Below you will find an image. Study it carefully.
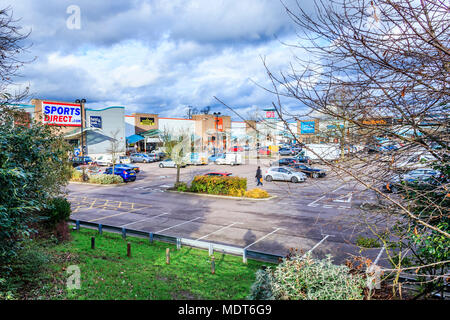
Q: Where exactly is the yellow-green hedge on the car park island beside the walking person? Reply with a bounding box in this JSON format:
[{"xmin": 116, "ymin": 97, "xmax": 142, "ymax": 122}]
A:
[{"xmin": 190, "ymin": 176, "xmax": 247, "ymax": 196}]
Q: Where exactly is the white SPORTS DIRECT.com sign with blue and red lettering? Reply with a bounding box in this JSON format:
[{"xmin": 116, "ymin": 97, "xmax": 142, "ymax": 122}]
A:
[{"xmin": 42, "ymin": 101, "xmax": 81, "ymax": 127}]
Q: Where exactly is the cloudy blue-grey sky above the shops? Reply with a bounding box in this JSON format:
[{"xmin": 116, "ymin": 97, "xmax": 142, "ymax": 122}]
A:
[{"xmin": 4, "ymin": 0, "xmax": 308, "ymax": 117}]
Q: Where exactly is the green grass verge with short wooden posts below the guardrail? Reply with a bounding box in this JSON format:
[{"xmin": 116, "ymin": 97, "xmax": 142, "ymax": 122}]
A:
[{"xmin": 32, "ymin": 229, "xmax": 269, "ymax": 300}]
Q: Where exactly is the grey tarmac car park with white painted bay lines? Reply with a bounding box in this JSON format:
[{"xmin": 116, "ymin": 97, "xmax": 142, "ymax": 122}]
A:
[{"xmin": 68, "ymin": 159, "xmax": 386, "ymax": 263}]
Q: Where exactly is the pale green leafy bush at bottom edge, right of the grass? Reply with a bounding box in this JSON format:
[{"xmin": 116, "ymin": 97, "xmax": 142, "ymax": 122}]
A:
[{"xmin": 249, "ymin": 255, "xmax": 365, "ymax": 300}]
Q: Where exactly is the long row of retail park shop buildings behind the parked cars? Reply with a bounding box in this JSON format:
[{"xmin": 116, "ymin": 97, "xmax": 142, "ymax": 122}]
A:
[{"xmin": 16, "ymin": 99, "xmax": 426, "ymax": 158}]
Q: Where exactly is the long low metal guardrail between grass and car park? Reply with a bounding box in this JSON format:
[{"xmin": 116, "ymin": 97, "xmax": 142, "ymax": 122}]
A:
[{"xmin": 69, "ymin": 219, "xmax": 284, "ymax": 263}]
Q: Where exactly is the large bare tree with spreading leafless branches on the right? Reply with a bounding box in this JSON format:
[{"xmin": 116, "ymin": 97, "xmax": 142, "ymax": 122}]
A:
[{"xmin": 218, "ymin": 0, "xmax": 450, "ymax": 294}]
